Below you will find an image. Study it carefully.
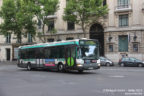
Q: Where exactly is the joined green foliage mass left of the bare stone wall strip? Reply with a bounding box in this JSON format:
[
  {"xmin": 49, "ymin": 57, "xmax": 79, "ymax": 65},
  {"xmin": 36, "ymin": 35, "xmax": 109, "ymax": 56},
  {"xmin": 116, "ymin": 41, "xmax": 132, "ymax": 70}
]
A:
[{"xmin": 0, "ymin": 0, "xmax": 58, "ymax": 41}]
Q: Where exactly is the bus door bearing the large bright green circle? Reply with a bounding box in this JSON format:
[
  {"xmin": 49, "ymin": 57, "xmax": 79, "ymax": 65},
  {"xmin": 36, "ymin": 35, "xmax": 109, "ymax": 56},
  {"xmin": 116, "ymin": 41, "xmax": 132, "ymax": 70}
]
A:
[{"xmin": 66, "ymin": 46, "xmax": 76, "ymax": 68}]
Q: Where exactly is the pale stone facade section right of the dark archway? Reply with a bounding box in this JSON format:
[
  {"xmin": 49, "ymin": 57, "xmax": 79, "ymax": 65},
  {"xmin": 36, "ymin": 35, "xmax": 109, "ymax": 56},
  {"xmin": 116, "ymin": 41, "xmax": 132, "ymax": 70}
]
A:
[{"xmin": 104, "ymin": 0, "xmax": 144, "ymax": 62}]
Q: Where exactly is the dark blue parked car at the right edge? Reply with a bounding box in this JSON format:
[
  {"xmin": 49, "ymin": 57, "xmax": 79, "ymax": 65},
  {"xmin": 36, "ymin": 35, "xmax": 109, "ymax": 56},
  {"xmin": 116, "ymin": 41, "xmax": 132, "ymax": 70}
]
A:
[{"xmin": 119, "ymin": 57, "xmax": 144, "ymax": 67}]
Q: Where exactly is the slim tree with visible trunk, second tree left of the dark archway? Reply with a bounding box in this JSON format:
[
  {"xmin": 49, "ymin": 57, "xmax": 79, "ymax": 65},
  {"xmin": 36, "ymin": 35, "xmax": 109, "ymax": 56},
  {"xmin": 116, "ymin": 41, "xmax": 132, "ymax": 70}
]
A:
[{"xmin": 36, "ymin": 0, "xmax": 58, "ymax": 42}]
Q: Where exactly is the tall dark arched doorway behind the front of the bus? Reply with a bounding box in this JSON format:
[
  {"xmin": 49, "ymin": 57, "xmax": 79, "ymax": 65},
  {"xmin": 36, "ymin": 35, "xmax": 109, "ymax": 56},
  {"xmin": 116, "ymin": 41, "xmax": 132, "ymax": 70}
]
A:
[{"xmin": 90, "ymin": 23, "xmax": 104, "ymax": 56}]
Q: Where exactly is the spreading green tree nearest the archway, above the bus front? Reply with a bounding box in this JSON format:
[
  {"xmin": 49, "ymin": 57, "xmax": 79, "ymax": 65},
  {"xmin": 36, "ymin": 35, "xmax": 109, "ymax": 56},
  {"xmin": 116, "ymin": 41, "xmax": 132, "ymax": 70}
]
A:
[{"xmin": 63, "ymin": 0, "xmax": 108, "ymax": 37}]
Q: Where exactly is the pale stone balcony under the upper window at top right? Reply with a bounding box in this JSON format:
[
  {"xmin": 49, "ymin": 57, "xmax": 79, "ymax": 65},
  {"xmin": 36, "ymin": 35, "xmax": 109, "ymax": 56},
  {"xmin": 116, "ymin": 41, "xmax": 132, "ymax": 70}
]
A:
[{"xmin": 115, "ymin": 4, "xmax": 132, "ymax": 13}]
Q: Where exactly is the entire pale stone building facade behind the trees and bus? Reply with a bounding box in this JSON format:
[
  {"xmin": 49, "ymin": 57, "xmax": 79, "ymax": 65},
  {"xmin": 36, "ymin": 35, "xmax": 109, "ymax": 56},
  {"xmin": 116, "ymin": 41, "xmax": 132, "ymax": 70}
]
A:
[{"xmin": 0, "ymin": 0, "xmax": 144, "ymax": 62}]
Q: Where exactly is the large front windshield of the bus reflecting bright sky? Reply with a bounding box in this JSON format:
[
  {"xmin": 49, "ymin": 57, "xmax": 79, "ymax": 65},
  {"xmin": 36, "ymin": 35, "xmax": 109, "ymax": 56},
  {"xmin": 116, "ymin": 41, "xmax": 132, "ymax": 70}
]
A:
[{"xmin": 80, "ymin": 40, "xmax": 99, "ymax": 59}]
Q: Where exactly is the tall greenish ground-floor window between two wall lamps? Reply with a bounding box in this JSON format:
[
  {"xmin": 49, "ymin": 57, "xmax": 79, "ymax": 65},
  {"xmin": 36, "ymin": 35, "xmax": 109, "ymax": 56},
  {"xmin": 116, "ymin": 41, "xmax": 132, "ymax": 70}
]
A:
[{"xmin": 119, "ymin": 35, "xmax": 128, "ymax": 52}]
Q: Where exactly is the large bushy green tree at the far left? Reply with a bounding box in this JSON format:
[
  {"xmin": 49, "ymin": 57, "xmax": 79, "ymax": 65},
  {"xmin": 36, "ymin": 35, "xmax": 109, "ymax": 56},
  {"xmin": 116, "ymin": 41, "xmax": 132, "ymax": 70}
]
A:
[{"xmin": 0, "ymin": 0, "xmax": 36, "ymax": 43}]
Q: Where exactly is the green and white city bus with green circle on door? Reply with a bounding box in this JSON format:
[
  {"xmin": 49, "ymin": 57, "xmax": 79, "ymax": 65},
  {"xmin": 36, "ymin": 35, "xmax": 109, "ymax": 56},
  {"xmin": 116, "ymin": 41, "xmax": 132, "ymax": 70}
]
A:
[{"xmin": 18, "ymin": 39, "xmax": 100, "ymax": 72}]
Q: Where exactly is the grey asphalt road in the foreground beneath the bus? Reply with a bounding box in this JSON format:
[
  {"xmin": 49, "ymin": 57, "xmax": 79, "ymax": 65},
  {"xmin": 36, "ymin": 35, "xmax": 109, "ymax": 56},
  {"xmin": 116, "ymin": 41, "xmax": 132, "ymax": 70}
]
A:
[{"xmin": 0, "ymin": 64, "xmax": 144, "ymax": 96}]
